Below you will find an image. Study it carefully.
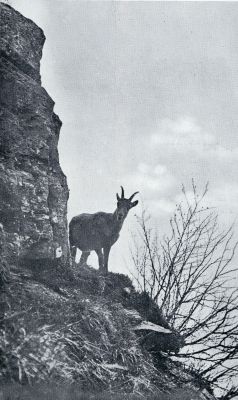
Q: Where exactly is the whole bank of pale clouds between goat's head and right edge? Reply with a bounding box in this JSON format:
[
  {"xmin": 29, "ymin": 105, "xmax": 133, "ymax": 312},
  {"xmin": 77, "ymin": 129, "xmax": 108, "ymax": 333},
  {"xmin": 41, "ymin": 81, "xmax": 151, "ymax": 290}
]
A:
[{"xmin": 125, "ymin": 117, "xmax": 238, "ymax": 224}]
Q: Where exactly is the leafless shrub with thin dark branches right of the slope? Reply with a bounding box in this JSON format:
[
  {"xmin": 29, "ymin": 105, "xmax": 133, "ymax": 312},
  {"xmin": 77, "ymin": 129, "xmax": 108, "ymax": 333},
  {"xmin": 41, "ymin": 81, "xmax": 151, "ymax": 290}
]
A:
[{"xmin": 131, "ymin": 182, "xmax": 238, "ymax": 398}]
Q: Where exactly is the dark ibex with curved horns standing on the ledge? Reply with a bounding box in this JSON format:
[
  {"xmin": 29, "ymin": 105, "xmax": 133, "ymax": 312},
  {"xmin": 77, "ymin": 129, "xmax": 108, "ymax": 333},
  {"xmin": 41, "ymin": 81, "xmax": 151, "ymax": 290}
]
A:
[{"xmin": 69, "ymin": 186, "xmax": 139, "ymax": 274}]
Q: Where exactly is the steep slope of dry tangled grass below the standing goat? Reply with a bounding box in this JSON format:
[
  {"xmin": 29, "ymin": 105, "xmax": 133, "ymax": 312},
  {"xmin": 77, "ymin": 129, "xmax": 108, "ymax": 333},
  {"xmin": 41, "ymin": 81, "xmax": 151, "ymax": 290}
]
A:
[{"xmin": 0, "ymin": 269, "xmax": 212, "ymax": 400}]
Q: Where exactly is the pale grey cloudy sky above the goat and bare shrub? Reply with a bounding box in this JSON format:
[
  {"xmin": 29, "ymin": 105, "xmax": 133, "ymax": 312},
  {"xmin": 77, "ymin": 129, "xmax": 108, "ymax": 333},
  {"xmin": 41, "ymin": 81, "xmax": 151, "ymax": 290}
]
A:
[{"xmin": 8, "ymin": 0, "xmax": 238, "ymax": 271}]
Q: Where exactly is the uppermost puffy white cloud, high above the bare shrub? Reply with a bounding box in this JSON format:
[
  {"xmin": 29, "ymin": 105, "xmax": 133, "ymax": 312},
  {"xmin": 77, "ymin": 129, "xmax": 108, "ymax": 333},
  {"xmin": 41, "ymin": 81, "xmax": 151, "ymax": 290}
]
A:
[{"xmin": 149, "ymin": 117, "xmax": 238, "ymax": 161}]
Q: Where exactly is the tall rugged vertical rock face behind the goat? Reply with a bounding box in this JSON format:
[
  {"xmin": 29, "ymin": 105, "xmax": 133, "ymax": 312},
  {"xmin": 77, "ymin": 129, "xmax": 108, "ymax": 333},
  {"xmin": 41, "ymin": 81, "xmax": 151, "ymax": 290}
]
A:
[{"xmin": 0, "ymin": 3, "xmax": 69, "ymax": 265}]
